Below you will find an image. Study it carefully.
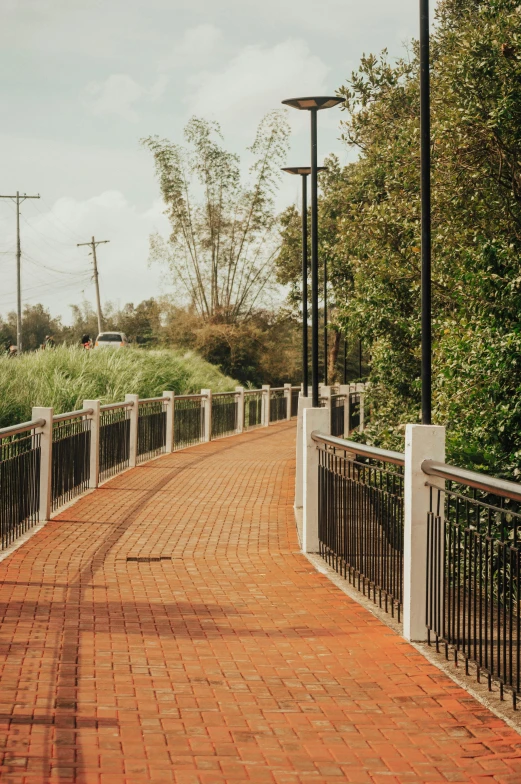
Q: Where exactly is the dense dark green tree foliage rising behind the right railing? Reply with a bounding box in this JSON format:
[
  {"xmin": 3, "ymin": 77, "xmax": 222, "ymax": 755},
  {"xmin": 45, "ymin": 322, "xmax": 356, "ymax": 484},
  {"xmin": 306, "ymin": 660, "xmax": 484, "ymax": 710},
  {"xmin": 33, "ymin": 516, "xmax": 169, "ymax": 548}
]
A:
[{"xmin": 278, "ymin": 0, "xmax": 521, "ymax": 476}]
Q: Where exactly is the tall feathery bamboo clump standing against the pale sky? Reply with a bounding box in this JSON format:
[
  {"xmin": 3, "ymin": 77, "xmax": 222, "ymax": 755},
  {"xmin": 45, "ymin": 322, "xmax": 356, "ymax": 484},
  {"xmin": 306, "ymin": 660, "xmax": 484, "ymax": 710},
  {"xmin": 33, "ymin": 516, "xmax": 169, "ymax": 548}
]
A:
[{"xmin": 143, "ymin": 112, "xmax": 289, "ymax": 324}]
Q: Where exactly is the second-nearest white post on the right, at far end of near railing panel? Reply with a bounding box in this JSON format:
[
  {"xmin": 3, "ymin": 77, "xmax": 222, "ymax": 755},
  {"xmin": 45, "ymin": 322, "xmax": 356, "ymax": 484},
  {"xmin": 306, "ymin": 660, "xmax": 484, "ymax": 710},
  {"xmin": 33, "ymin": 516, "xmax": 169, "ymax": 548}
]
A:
[{"xmin": 302, "ymin": 408, "xmax": 330, "ymax": 553}]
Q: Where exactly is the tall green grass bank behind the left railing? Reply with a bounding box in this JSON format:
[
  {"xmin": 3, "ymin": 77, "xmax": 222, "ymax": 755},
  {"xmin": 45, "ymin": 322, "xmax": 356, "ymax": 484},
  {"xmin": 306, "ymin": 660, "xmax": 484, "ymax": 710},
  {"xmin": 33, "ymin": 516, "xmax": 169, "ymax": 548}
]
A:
[{"xmin": 0, "ymin": 346, "xmax": 236, "ymax": 427}]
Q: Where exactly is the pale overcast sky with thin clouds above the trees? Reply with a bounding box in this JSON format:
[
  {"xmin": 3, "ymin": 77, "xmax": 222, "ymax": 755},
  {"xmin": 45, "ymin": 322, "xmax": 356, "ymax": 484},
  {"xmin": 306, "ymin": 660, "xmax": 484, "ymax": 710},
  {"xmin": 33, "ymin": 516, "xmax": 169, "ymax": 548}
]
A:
[{"xmin": 0, "ymin": 0, "xmax": 418, "ymax": 321}]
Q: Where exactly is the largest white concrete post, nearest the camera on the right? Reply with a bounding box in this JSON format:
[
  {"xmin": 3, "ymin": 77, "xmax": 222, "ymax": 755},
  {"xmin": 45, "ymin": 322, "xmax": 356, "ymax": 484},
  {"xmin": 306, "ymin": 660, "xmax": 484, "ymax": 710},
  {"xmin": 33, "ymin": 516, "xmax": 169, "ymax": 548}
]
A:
[{"xmin": 403, "ymin": 425, "xmax": 445, "ymax": 642}]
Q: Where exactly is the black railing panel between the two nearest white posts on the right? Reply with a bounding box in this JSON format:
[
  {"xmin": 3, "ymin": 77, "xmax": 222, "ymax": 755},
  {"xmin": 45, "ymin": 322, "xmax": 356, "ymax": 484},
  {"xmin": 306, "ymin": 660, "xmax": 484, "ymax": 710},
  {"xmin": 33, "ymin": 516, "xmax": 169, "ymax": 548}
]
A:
[{"xmin": 313, "ymin": 434, "xmax": 404, "ymax": 620}]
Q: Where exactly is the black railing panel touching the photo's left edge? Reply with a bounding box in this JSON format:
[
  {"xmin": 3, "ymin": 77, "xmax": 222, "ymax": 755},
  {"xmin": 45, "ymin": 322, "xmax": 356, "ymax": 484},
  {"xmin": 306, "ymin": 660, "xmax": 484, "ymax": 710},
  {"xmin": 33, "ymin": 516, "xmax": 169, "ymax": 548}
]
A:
[{"xmin": 0, "ymin": 425, "xmax": 41, "ymax": 550}]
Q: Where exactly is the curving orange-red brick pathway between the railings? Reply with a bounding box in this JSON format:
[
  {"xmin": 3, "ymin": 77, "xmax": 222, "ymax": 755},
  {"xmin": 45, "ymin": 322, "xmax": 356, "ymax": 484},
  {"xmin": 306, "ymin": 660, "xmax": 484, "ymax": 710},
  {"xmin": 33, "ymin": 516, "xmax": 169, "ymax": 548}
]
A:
[{"xmin": 0, "ymin": 423, "xmax": 521, "ymax": 784}]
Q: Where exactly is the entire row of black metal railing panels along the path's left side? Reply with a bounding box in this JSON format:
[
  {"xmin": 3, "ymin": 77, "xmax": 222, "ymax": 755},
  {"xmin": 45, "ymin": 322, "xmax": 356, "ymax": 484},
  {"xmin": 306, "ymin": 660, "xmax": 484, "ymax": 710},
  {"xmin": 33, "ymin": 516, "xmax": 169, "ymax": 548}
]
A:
[{"xmin": 0, "ymin": 387, "xmax": 299, "ymax": 548}]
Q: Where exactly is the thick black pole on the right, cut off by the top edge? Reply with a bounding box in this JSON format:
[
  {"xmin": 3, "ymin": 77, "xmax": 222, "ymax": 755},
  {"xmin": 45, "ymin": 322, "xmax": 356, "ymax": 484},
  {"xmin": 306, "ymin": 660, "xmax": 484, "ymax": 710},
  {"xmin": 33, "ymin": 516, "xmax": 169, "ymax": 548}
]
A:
[{"xmin": 420, "ymin": 0, "xmax": 432, "ymax": 425}]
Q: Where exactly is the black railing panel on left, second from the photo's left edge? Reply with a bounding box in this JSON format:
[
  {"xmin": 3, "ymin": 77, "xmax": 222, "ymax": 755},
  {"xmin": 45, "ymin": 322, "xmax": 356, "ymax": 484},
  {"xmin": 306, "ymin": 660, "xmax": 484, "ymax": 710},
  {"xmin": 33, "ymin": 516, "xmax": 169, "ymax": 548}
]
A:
[{"xmin": 51, "ymin": 412, "xmax": 91, "ymax": 510}]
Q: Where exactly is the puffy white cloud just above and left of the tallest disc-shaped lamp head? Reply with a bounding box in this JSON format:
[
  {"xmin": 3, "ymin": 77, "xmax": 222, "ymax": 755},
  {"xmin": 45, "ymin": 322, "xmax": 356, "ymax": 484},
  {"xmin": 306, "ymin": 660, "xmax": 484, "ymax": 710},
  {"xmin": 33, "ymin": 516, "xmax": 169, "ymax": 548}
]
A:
[{"xmin": 187, "ymin": 39, "xmax": 329, "ymax": 122}]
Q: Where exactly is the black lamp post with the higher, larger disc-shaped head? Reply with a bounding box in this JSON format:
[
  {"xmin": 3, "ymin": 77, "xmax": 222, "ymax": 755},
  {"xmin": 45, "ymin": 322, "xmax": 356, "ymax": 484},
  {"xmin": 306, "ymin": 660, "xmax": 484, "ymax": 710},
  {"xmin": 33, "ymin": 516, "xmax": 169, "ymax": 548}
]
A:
[{"xmin": 282, "ymin": 96, "xmax": 345, "ymax": 408}]
